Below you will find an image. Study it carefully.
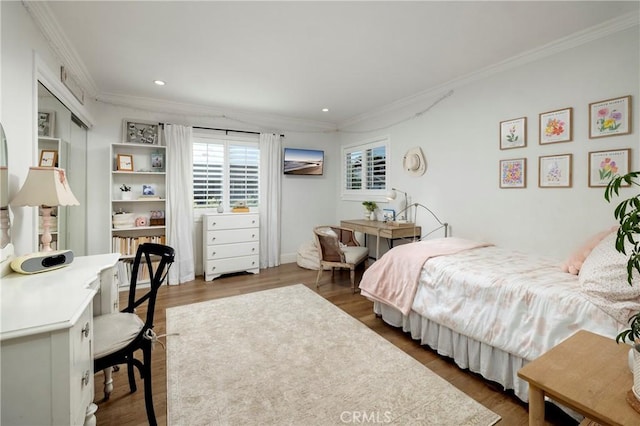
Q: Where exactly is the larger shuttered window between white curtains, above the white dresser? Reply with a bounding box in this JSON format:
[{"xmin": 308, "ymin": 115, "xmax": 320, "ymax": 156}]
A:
[{"xmin": 193, "ymin": 135, "xmax": 260, "ymax": 213}]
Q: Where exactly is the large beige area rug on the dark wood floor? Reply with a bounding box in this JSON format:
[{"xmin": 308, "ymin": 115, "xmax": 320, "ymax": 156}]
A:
[{"xmin": 167, "ymin": 284, "xmax": 500, "ymax": 426}]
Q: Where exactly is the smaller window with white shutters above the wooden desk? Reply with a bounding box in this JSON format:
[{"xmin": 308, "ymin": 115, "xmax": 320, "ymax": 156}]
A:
[{"xmin": 342, "ymin": 138, "xmax": 389, "ymax": 200}]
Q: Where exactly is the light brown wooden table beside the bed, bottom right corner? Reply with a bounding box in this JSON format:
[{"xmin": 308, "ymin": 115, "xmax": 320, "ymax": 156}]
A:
[{"xmin": 518, "ymin": 330, "xmax": 640, "ymax": 426}]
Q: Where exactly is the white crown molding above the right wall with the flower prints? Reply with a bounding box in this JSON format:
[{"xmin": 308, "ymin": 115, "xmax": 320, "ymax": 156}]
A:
[{"xmin": 338, "ymin": 12, "xmax": 640, "ymax": 129}]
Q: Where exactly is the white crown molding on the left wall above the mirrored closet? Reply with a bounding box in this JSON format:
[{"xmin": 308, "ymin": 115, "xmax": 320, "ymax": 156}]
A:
[{"xmin": 22, "ymin": 0, "xmax": 99, "ymax": 97}]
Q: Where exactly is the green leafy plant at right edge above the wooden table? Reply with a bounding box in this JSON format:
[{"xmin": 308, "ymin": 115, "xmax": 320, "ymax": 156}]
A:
[{"xmin": 604, "ymin": 171, "xmax": 640, "ymax": 344}]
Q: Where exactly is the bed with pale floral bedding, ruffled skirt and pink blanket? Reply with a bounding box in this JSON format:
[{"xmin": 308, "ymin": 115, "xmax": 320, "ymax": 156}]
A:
[{"xmin": 360, "ymin": 236, "xmax": 640, "ymax": 402}]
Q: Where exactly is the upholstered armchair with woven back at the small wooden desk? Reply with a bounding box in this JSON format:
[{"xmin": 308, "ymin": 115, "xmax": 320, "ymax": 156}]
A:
[{"xmin": 313, "ymin": 226, "xmax": 369, "ymax": 293}]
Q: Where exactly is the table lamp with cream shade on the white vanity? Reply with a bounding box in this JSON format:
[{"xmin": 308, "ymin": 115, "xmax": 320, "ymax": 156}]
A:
[{"xmin": 9, "ymin": 167, "xmax": 80, "ymax": 252}]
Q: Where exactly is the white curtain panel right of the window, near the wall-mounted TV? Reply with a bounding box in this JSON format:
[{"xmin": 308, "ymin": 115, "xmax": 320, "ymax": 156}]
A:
[{"xmin": 260, "ymin": 133, "xmax": 282, "ymax": 268}]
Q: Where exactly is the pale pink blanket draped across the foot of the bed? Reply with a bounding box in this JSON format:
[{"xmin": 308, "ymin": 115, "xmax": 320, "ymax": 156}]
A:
[{"xmin": 360, "ymin": 237, "xmax": 491, "ymax": 315}]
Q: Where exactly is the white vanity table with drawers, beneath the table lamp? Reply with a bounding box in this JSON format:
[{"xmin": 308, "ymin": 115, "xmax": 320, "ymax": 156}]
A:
[{"xmin": 0, "ymin": 253, "xmax": 120, "ymax": 425}]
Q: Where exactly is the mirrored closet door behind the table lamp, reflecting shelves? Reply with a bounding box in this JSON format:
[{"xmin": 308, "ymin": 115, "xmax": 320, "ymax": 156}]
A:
[{"xmin": 37, "ymin": 82, "xmax": 87, "ymax": 256}]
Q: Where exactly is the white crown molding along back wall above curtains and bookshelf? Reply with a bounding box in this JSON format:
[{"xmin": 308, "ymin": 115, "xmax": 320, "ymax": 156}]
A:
[{"xmin": 96, "ymin": 93, "xmax": 336, "ymax": 133}]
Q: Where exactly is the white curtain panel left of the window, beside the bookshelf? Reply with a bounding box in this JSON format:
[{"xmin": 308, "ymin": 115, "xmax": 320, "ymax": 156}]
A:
[{"xmin": 164, "ymin": 124, "xmax": 195, "ymax": 284}]
